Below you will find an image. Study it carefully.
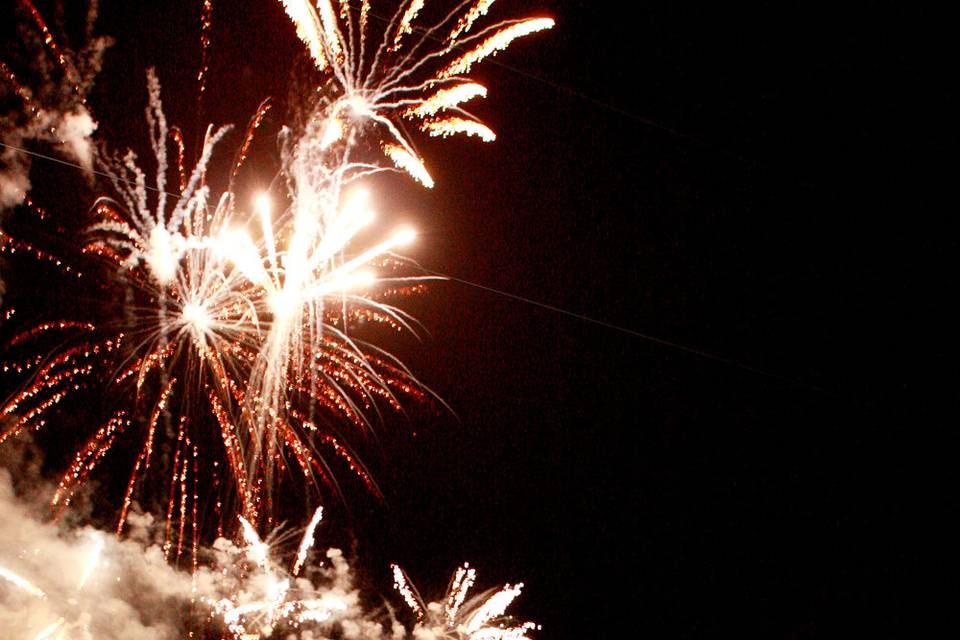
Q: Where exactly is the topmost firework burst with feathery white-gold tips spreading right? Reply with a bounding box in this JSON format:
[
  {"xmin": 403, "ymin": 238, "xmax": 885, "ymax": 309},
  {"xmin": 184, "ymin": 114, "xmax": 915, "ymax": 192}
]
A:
[{"xmin": 280, "ymin": 0, "xmax": 554, "ymax": 188}]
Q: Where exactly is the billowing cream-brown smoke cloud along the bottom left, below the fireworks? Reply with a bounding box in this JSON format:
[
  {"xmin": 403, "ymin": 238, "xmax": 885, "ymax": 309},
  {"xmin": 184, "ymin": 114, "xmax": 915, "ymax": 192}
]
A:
[{"xmin": 0, "ymin": 442, "xmax": 407, "ymax": 640}]
